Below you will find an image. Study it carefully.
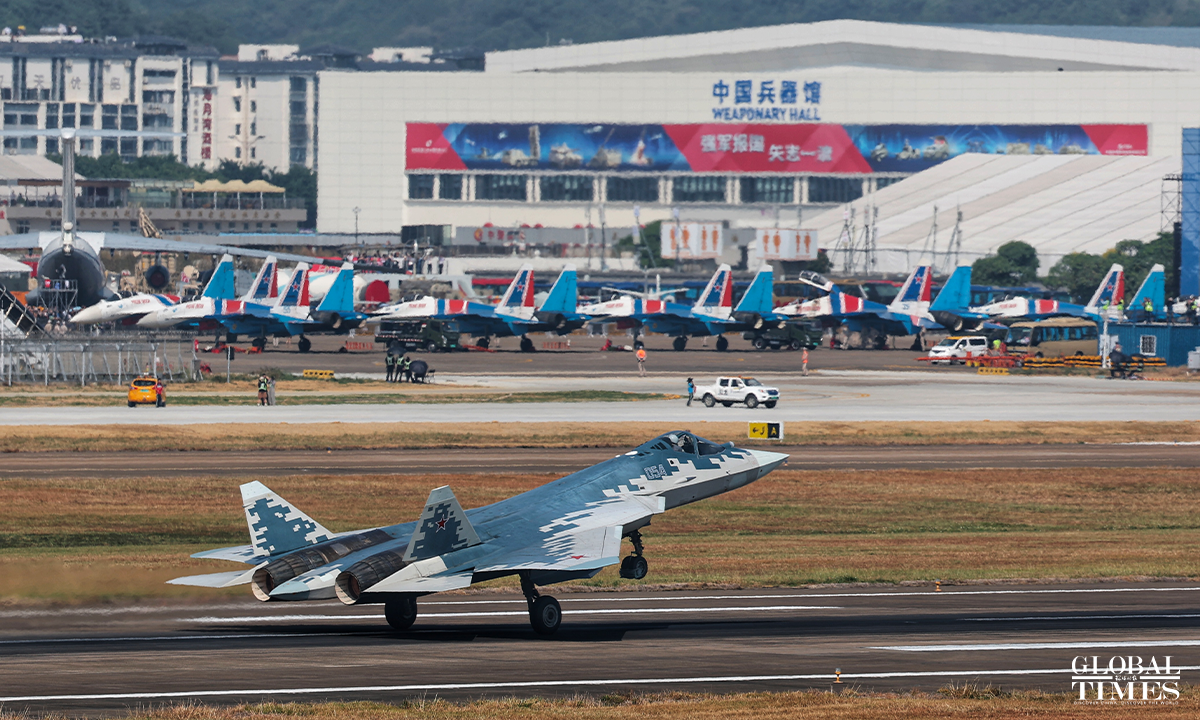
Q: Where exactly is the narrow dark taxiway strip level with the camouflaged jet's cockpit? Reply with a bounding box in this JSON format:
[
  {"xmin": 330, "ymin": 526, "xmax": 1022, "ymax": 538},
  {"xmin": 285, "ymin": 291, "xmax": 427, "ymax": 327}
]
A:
[{"xmin": 0, "ymin": 444, "xmax": 1200, "ymax": 478}]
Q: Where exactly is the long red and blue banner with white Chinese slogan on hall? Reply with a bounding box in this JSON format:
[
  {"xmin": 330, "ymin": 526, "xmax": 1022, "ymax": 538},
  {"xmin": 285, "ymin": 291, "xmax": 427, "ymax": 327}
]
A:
[{"xmin": 406, "ymin": 122, "xmax": 1148, "ymax": 174}]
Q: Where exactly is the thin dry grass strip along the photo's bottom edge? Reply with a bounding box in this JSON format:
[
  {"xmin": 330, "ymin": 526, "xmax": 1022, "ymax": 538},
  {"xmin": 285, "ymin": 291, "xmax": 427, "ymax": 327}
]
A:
[{"xmin": 49, "ymin": 685, "xmax": 1200, "ymax": 720}]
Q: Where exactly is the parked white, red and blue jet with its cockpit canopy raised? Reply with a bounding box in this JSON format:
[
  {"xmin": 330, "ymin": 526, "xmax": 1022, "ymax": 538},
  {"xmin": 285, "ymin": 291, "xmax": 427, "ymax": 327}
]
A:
[{"xmin": 776, "ymin": 265, "xmax": 940, "ymax": 337}]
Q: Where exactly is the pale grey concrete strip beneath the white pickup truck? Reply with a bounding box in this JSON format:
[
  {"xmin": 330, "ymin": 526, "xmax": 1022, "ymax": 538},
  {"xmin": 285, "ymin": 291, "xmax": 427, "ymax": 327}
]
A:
[{"xmin": 9, "ymin": 368, "xmax": 1200, "ymax": 425}]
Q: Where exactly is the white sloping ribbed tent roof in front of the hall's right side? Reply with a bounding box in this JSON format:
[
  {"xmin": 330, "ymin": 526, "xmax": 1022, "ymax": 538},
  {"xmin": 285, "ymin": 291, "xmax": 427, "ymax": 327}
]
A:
[{"xmin": 804, "ymin": 154, "xmax": 1181, "ymax": 272}]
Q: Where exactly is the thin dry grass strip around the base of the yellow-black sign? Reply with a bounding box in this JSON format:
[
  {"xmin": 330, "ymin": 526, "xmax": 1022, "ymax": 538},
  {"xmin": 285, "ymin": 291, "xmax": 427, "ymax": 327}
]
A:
[{"xmin": 7, "ymin": 420, "xmax": 1200, "ymax": 452}]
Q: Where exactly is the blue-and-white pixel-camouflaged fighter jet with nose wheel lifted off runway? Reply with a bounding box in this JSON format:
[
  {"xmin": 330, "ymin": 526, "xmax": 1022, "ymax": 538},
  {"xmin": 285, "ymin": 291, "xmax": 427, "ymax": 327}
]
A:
[{"xmin": 169, "ymin": 431, "xmax": 787, "ymax": 635}]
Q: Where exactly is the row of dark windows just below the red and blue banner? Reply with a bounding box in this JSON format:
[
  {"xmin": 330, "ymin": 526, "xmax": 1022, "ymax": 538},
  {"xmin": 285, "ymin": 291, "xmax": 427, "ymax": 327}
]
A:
[{"xmin": 408, "ymin": 173, "xmax": 902, "ymax": 205}]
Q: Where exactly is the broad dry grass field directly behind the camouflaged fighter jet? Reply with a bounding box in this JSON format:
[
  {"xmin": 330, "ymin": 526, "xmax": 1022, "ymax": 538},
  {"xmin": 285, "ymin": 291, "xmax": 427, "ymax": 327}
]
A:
[{"xmin": 0, "ymin": 468, "xmax": 1200, "ymax": 602}]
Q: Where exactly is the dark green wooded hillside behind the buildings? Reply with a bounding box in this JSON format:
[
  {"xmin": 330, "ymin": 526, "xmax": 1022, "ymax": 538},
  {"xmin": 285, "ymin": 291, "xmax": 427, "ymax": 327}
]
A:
[{"xmin": 0, "ymin": 0, "xmax": 1200, "ymax": 53}]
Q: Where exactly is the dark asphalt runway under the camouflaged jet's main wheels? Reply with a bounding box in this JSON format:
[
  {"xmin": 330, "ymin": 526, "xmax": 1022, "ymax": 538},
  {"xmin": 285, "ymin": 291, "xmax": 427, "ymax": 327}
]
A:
[{"xmin": 0, "ymin": 585, "xmax": 1200, "ymax": 715}]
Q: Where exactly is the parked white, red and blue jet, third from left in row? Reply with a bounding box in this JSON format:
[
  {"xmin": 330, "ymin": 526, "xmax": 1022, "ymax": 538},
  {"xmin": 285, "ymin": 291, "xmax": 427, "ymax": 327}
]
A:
[{"xmin": 370, "ymin": 264, "xmax": 588, "ymax": 352}]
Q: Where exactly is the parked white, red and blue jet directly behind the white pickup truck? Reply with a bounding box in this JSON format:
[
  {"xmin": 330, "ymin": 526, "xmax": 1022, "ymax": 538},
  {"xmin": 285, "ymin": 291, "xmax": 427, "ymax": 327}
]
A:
[{"xmin": 581, "ymin": 264, "xmax": 784, "ymax": 350}]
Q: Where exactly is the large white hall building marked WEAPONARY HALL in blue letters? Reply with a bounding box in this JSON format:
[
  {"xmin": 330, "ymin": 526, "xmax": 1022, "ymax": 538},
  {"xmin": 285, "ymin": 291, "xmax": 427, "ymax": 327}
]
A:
[{"xmin": 318, "ymin": 20, "xmax": 1200, "ymax": 271}]
